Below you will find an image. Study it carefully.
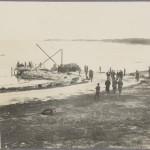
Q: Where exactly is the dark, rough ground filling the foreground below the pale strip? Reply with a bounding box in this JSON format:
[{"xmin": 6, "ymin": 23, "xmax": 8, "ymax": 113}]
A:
[{"xmin": 0, "ymin": 78, "xmax": 150, "ymax": 148}]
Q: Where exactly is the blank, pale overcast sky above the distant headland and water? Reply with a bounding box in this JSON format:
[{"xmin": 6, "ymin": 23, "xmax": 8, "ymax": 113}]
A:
[{"xmin": 0, "ymin": 2, "xmax": 150, "ymax": 40}]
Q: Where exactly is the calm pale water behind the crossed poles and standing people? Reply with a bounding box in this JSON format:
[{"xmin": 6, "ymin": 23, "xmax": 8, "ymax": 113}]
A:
[{"xmin": 0, "ymin": 41, "xmax": 150, "ymax": 80}]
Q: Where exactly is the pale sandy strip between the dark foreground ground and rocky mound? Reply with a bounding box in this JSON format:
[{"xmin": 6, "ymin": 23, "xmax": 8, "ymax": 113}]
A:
[{"xmin": 0, "ymin": 72, "xmax": 141, "ymax": 106}]
